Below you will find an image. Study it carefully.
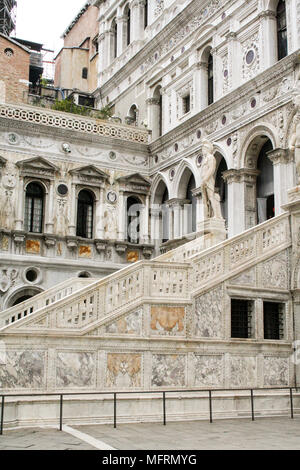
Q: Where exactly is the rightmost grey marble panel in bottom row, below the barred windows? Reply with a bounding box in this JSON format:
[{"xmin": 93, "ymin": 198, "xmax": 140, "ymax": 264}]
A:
[{"xmin": 264, "ymin": 356, "xmax": 289, "ymax": 387}]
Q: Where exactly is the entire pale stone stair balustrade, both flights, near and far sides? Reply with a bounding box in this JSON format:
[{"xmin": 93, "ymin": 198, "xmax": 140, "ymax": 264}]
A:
[{"xmin": 0, "ymin": 213, "xmax": 291, "ymax": 335}]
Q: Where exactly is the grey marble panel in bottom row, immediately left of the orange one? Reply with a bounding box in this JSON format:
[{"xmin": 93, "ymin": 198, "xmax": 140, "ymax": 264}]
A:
[{"xmin": 56, "ymin": 352, "xmax": 95, "ymax": 388}]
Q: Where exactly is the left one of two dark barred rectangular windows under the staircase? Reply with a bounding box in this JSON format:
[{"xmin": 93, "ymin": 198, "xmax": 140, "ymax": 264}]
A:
[{"xmin": 231, "ymin": 299, "xmax": 253, "ymax": 338}]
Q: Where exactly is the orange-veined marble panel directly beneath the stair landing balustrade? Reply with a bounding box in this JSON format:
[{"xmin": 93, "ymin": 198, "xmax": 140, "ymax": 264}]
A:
[{"xmin": 150, "ymin": 306, "xmax": 185, "ymax": 335}]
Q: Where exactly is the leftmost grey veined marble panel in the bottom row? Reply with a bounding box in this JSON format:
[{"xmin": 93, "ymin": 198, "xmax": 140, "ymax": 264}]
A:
[{"xmin": 0, "ymin": 351, "xmax": 46, "ymax": 389}]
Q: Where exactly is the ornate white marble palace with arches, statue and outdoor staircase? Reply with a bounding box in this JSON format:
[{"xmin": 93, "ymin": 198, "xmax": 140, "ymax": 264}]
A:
[{"xmin": 0, "ymin": 0, "xmax": 300, "ymax": 422}]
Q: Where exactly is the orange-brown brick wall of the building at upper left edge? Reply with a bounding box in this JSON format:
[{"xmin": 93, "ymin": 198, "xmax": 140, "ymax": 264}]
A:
[{"xmin": 0, "ymin": 36, "xmax": 30, "ymax": 103}]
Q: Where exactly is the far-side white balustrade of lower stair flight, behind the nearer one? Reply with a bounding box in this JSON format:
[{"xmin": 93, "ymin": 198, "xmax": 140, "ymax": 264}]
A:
[{"xmin": 0, "ymin": 278, "xmax": 96, "ymax": 327}]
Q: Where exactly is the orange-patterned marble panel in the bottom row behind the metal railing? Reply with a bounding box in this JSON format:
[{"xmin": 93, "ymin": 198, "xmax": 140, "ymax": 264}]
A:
[{"xmin": 106, "ymin": 353, "xmax": 142, "ymax": 388}]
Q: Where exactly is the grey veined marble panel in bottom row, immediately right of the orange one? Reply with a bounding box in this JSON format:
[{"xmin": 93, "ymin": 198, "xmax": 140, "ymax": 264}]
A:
[{"xmin": 151, "ymin": 354, "xmax": 186, "ymax": 387}]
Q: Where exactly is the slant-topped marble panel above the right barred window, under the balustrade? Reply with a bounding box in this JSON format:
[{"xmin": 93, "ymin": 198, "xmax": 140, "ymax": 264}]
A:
[{"xmin": 261, "ymin": 251, "xmax": 288, "ymax": 289}]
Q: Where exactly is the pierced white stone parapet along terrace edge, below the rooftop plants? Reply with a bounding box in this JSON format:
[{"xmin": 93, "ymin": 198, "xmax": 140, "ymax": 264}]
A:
[{"xmin": 0, "ymin": 104, "xmax": 149, "ymax": 144}]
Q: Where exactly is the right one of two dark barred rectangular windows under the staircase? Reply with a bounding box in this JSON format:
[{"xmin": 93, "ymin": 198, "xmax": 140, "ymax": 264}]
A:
[{"xmin": 264, "ymin": 302, "xmax": 284, "ymax": 339}]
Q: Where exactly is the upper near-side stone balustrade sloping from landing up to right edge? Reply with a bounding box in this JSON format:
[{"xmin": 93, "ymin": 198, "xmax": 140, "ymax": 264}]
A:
[{"xmin": 189, "ymin": 213, "xmax": 291, "ymax": 291}]
